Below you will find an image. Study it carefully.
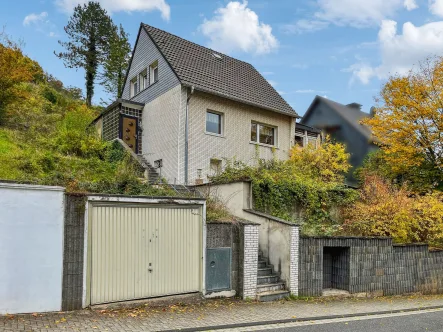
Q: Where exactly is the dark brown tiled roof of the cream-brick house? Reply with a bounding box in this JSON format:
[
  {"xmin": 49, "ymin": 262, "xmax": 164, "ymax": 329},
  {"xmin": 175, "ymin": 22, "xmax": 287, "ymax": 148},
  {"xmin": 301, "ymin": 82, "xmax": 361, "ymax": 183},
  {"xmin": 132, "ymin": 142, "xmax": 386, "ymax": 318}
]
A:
[{"xmin": 142, "ymin": 24, "xmax": 298, "ymax": 117}]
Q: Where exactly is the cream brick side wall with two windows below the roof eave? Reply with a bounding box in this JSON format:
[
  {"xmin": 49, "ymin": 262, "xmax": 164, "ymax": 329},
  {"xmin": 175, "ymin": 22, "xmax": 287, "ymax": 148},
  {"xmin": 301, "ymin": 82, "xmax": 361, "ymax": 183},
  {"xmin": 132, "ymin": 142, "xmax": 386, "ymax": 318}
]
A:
[{"xmin": 188, "ymin": 91, "xmax": 295, "ymax": 184}]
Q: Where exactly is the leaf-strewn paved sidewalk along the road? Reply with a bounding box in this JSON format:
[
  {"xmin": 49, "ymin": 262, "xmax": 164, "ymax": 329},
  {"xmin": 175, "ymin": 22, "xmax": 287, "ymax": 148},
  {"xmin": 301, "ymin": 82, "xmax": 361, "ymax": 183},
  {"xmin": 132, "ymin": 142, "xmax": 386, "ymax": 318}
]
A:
[{"xmin": 0, "ymin": 295, "xmax": 443, "ymax": 332}]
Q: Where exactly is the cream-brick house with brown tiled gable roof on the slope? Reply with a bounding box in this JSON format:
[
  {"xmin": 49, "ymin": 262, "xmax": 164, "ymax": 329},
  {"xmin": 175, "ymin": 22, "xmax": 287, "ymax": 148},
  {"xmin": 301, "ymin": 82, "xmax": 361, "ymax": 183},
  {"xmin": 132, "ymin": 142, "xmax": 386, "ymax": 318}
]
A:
[{"xmin": 95, "ymin": 24, "xmax": 298, "ymax": 184}]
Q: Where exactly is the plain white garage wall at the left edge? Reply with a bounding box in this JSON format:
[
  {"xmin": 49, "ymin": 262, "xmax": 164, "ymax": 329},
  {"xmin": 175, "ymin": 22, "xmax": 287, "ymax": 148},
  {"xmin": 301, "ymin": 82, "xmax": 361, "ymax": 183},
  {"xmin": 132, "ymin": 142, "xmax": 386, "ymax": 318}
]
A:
[{"xmin": 0, "ymin": 183, "xmax": 64, "ymax": 314}]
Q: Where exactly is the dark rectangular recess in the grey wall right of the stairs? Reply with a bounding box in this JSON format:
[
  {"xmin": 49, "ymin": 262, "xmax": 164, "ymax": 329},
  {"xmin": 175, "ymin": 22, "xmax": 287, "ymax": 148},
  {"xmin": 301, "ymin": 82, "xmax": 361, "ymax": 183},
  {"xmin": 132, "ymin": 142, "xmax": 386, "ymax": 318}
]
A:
[{"xmin": 323, "ymin": 247, "xmax": 350, "ymax": 291}]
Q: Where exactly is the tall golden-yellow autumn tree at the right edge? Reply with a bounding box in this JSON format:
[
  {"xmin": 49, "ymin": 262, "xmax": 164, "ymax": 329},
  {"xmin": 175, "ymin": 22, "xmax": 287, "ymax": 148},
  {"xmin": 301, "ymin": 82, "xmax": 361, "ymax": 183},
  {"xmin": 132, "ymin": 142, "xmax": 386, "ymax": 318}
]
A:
[{"xmin": 363, "ymin": 57, "xmax": 443, "ymax": 187}]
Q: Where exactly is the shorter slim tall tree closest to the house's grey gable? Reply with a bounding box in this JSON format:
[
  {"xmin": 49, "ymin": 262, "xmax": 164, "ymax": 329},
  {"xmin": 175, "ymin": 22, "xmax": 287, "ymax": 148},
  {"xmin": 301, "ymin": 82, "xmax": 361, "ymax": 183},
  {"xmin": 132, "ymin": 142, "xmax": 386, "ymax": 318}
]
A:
[{"xmin": 101, "ymin": 24, "xmax": 131, "ymax": 98}]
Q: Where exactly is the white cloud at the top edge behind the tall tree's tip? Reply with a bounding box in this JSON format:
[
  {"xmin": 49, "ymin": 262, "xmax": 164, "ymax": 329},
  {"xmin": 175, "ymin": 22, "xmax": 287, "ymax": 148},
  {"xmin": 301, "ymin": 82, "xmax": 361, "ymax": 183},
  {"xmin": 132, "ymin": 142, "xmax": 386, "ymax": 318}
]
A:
[{"xmin": 55, "ymin": 0, "xmax": 171, "ymax": 21}]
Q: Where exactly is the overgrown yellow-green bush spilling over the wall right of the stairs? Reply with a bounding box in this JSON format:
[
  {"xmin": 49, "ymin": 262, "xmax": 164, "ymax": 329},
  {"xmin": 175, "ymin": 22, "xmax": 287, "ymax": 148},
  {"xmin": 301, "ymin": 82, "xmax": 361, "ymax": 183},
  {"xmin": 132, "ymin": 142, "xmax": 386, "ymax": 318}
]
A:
[{"xmin": 212, "ymin": 142, "xmax": 357, "ymax": 234}]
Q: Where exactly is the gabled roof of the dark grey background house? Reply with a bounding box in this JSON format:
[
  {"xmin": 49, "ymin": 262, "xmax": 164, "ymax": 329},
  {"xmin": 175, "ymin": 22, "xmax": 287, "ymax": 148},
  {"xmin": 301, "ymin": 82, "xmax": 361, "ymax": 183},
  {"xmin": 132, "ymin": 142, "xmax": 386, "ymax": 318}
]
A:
[{"xmin": 300, "ymin": 96, "xmax": 373, "ymax": 140}]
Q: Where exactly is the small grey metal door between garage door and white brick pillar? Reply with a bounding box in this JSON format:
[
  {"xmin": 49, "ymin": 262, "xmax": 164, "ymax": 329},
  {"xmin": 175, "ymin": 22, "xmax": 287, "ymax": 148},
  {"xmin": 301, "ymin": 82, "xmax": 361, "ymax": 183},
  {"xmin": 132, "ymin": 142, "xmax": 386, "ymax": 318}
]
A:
[{"xmin": 206, "ymin": 248, "xmax": 231, "ymax": 291}]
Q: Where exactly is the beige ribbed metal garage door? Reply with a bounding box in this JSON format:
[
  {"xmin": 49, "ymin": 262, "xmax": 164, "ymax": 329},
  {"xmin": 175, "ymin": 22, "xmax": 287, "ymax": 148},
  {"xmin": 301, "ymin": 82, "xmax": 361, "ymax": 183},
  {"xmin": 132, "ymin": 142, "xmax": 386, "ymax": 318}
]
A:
[{"xmin": 89, "ymin": 204, "xmax": 202, "ymax": 304}]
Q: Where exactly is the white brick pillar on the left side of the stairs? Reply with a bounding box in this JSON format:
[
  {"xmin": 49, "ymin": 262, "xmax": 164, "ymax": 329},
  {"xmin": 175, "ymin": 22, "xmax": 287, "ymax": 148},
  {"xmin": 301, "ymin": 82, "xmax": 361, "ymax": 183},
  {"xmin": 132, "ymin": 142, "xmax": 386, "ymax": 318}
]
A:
[{"xmin": 243, "ymin": 225, "xmax": 259, "ymax": 299}]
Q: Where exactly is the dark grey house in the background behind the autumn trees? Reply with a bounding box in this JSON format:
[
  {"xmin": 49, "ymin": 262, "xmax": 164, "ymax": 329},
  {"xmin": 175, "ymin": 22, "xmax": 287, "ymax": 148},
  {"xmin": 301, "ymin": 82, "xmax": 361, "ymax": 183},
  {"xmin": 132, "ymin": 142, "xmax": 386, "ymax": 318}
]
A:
[{"xmin": 300, "ymin": 96, "xmax": 377, "ymax": 185}]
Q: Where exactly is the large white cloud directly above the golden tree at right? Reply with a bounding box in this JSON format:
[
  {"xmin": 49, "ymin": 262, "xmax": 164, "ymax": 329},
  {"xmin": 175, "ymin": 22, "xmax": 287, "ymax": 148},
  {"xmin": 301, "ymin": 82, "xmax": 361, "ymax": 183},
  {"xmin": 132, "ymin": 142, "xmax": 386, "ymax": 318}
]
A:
[{"xmin": 343, "ymin": 20, "xmax": 443, "ymax": 84}]
